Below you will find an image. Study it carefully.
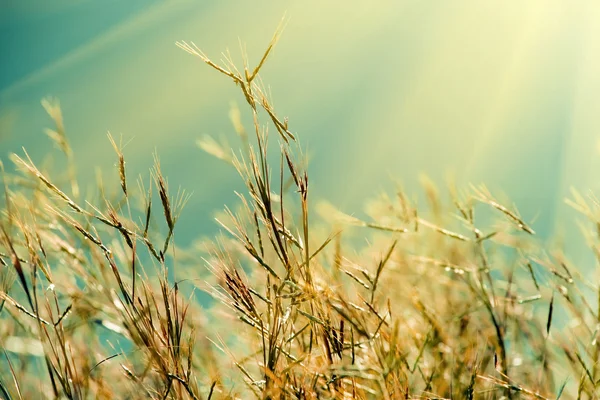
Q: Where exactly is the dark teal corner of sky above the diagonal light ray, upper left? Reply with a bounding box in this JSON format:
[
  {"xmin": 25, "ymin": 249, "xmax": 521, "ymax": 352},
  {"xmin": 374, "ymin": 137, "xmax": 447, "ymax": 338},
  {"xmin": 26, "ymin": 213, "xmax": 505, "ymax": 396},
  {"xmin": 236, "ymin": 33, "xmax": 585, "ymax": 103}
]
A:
[{"xmin": 0, "ymin": 0, "xmax": 163, "ymax": 90}]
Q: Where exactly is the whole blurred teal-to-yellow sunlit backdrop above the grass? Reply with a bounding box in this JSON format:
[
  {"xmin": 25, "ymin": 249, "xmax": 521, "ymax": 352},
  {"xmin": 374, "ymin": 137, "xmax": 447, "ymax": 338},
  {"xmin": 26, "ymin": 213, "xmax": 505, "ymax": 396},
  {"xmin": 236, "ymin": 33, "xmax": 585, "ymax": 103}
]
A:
[{"xmin": 0, "ymin": 0, "xmax": 600, "ymax": 266}]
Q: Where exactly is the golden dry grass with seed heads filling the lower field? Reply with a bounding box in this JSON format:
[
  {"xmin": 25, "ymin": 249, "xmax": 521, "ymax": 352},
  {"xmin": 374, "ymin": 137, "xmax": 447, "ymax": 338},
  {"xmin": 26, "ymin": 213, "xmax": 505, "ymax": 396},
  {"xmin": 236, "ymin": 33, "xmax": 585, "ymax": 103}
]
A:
[{"xmin": 0, "ymin": 26, "xmax": 600, "ymax": 399}]
